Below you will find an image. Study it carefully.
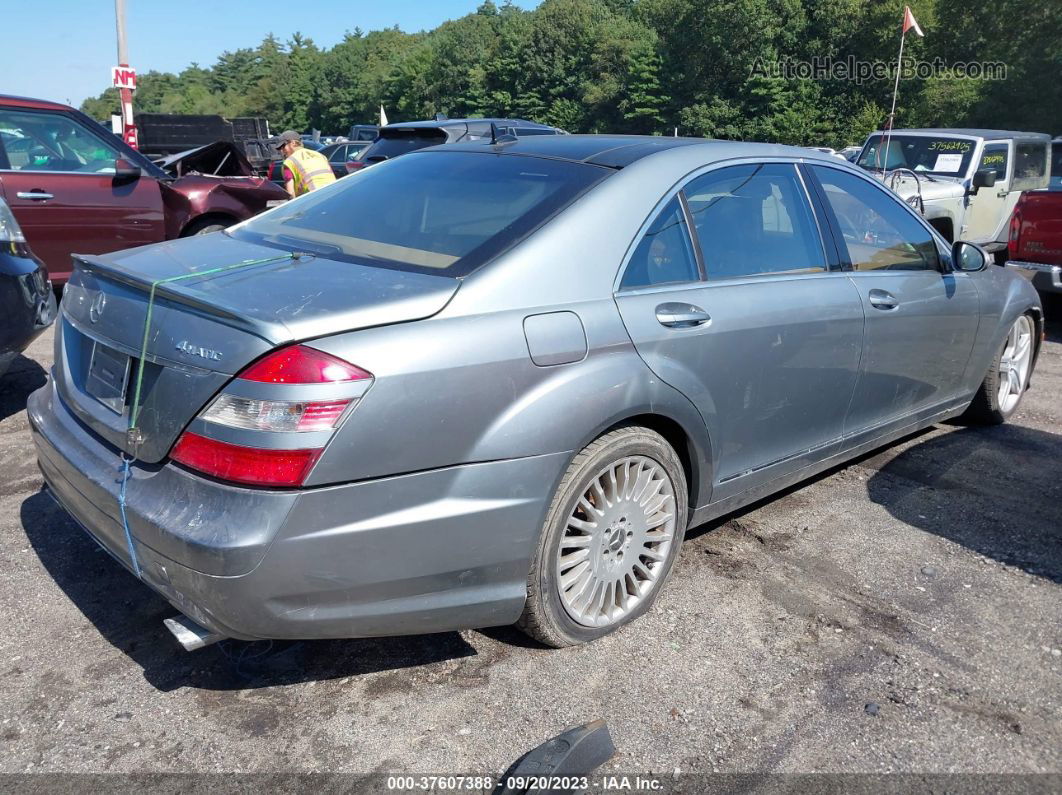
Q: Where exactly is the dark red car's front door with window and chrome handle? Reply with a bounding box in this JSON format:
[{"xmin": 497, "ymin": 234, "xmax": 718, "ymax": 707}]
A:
[{"xmin": 0, "ymin": 107, "xmax": 165, "ymax": 281}]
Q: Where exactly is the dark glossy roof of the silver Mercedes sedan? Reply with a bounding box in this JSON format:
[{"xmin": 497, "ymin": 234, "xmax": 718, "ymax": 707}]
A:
[{"xmin": 433, "ymin": 135, "xmax": 840, "ymax": 169}]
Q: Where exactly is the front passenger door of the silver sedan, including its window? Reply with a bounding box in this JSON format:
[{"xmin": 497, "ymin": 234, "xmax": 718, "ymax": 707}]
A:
[{"xmin": 809, "ymin": 159, "xmax": 980, "ymax": 436}]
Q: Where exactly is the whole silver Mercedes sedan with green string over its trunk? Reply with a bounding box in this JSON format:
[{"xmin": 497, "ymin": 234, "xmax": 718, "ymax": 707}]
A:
[{"xmin": 29, "ymin": 136, "xmax": 1043, "ymax": 647}]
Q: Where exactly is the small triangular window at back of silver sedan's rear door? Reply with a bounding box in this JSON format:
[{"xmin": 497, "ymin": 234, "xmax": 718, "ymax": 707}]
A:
[{"xmin": 619, "ymin": 197, "xmax": 700, "ymax": 290}]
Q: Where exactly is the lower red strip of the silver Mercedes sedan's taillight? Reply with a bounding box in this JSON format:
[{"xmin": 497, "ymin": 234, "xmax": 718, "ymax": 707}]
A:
[{"xmin": 171, "ymin": 431, "xmax": 321, "ymax": 486}]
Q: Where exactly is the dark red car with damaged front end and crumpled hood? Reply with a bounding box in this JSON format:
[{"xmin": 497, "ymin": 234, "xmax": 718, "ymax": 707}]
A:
[{"xmin": 0, "ymin": 96, "xmax": 288, "ymax": 283}]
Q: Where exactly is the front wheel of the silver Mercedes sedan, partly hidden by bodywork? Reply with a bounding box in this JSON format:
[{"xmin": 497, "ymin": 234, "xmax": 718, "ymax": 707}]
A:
[{"xmin": 962, "ymin": 314, "xmax": 1037, "ymax": 425}]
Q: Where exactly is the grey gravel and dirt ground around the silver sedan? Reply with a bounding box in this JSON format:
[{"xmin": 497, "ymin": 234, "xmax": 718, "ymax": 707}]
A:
[{"xmin": 0, "ymin": 301, "xmax": 1062, "ymax": 777}]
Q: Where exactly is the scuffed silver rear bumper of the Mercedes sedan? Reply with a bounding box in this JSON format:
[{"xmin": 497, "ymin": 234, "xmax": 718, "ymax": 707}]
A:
[{"xmin": 28, "ymin": 375, "xmax": 568, "ymax": 639}]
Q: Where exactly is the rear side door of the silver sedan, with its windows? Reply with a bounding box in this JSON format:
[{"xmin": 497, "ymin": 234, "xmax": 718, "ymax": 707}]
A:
[{"xmin": 616, "ymin": 162, "xmax": 863, "ymax": 499}]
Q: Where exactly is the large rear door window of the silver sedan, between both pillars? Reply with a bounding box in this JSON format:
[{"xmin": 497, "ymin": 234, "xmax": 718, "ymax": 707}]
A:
[{"xmin": 685, "ymin": 163, "xmax": 826, "ymax": 281}]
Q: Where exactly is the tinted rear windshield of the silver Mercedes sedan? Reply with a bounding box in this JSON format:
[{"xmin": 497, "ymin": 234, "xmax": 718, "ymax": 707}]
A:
[{"xmin": 232, "ymin": 150, "xmax": 613, "ymax": 276}]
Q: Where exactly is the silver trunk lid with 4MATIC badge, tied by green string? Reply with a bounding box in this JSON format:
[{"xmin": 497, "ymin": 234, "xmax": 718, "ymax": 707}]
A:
[{"xmin": 55, "ymin": 235, "xmax": 460, "ymax": 463}]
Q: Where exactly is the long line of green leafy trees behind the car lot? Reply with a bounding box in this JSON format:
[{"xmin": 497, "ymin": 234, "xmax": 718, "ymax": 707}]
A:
[{"xmin": 82, "ymin": 0, "xmax": 1062, "ymax": 146}]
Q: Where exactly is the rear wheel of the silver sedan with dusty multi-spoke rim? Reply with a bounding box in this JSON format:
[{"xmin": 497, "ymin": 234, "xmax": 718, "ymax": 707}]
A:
[{"xmin": 517, "ymin": 426, "xmax": 688, "ymax": 649}]
